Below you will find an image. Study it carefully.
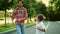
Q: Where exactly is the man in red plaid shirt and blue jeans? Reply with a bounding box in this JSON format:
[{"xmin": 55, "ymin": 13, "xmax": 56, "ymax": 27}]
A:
[{"xmin": 11, "ymin": 0, "xmax": 28, "ymax": 34}]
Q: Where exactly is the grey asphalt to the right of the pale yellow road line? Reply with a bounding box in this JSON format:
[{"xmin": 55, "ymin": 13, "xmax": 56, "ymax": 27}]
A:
[{"xmin": 46, "ymin": 22, "xmax": 60, "ymax": 34}]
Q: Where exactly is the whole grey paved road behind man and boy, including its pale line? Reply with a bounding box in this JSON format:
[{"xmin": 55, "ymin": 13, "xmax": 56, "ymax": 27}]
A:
[{"xmin": 1, "ymin": 22, "xmax": 60, "ymax": 34}]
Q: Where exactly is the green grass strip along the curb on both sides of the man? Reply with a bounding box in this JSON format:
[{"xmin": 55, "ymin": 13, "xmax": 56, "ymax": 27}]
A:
[{"xmin": 0, "ymin": 22, "xmax": 34, "ymax": 32}]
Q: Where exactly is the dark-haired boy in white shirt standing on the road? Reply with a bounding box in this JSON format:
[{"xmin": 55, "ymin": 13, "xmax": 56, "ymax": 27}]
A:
[{"xmin": 36, "ymin": 14, "xmax": 45, "ymax": 34}]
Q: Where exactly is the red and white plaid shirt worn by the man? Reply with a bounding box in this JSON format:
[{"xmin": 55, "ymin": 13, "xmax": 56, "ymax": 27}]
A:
[{"xmin": 12, "ymin": 7, "xmax": 28, "ymax": 23}]
